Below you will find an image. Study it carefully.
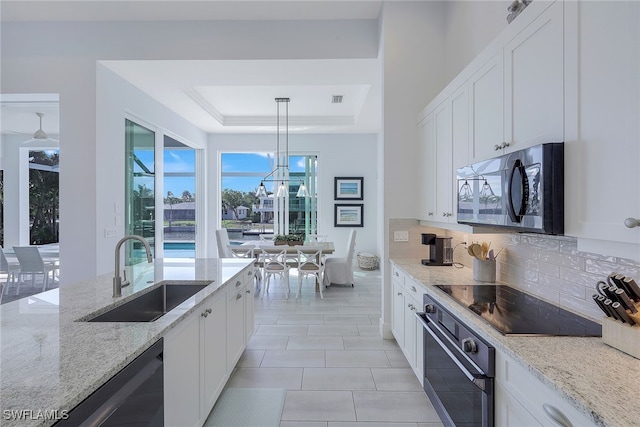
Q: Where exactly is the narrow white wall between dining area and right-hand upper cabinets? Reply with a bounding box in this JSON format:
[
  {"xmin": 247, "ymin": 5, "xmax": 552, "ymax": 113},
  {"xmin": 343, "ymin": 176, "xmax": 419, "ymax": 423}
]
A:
[{"xmin": 378, "ymin": 2, "xmax": 445, "ymax": 337}]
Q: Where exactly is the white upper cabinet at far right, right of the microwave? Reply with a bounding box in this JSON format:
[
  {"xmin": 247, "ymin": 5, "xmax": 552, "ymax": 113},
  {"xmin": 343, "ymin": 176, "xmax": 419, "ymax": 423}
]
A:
[{"xmin": 565, "ymin": 1, "xmax": 640, "ymax": 254}]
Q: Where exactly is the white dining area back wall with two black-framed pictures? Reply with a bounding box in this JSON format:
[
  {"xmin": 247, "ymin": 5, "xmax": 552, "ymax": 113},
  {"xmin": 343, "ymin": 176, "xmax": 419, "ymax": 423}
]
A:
[{"xmin": 207, "ymin": 134, "xmax": 382, "ymax": 260}]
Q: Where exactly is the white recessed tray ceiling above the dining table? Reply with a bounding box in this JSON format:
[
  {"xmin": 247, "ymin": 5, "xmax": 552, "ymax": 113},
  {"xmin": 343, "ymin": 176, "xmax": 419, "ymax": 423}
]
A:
[{"xmin": 102, "ymin": 59, "xmax": 381, "ymax": 133}]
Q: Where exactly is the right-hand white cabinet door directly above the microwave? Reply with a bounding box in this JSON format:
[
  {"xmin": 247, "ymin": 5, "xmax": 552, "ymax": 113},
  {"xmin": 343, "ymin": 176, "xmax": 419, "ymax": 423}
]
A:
[{"xmin": 500, "ymin": 1, "xmax": 564, "ymax": 154}]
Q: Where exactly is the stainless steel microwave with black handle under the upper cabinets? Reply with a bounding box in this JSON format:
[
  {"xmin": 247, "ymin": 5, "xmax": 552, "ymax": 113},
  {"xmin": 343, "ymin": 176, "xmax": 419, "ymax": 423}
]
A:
[{"xmin": 457, "ymin": 142, "xmax": 564, "ymax": 234}]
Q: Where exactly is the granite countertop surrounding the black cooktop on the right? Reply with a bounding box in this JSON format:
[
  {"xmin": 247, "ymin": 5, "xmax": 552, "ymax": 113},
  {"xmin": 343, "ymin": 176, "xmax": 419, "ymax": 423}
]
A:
[{"xmin": 391, "ymin": 259, "xmax": 640, "ymax": 426}]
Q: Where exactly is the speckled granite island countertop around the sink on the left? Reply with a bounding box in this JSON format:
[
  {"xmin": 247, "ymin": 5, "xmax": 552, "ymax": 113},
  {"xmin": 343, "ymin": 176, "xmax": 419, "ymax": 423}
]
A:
[{"xmin": 0, "ymin": 259, "xmax": 251, "ymax": 427}]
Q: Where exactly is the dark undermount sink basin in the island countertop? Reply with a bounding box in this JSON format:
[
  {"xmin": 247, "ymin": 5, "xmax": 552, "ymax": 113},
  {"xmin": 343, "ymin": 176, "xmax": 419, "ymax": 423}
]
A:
[{"xmin": 86, "ymin": 282, "xmax": 211, "ymax": 322}]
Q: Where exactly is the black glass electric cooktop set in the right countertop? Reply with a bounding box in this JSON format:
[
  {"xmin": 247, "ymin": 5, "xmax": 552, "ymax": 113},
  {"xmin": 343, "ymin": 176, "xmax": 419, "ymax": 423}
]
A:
[{"xmin": 436, "ymin": 285, "xmax": 602, "ymax": 337}]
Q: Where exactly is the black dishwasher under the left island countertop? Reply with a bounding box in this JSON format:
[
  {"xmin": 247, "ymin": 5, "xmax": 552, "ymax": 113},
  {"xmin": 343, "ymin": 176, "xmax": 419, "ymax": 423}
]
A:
[{"xmin": 55, "ymin": 338, "xmax": 164, "ymax": 427}]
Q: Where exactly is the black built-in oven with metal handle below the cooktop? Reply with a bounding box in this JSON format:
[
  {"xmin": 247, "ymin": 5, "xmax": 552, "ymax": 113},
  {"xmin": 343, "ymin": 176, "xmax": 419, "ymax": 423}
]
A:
[{"xmin": 416, "ymin": 295, "xmax": 495, "ymax": 427}]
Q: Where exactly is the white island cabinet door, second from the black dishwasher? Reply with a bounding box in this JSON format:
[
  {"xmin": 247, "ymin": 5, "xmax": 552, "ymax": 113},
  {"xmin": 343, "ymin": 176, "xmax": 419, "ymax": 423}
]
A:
[{"xmin": 201, "ymin": 295, "xmax": 227, "ymax": 419}]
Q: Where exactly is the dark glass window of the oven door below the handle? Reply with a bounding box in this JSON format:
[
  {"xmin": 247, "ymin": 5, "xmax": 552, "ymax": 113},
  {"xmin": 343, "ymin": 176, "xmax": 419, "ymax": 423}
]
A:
[{"xmin": 424, "ymin": 331, "xmax": 483, "ymax": 427}]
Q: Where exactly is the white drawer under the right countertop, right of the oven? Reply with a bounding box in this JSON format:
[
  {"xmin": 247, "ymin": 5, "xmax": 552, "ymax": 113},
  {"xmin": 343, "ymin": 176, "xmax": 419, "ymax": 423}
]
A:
[{"xmin": 496, "ymin": 352, "xmax": 595, "ymax": 427}]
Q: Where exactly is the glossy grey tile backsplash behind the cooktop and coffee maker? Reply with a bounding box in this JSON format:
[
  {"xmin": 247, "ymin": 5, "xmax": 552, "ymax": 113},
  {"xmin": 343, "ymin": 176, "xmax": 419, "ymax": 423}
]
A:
[{"xmin": 389, "ymin": 219, "xmax": 640, "ymax": 321}]
